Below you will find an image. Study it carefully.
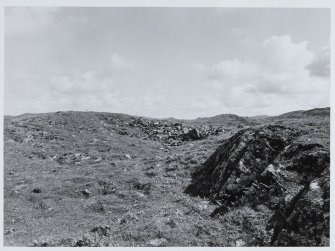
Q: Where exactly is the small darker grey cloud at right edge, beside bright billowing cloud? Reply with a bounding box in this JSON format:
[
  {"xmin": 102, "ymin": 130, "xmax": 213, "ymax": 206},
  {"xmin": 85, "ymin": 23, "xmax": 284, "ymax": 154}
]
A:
[{"xmin": 306, "ymin": 45, "xmax": 330, "ymax": 78}]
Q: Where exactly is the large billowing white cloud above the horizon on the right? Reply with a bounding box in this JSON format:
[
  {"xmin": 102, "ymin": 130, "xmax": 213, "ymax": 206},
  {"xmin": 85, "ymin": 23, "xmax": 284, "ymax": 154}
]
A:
[{"xmin": 204, "ymin": 35, "xmax": 329, "ymax": 115}]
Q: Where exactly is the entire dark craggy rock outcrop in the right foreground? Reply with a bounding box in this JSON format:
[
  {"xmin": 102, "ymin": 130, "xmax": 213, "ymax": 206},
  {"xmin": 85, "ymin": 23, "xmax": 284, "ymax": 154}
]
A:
[{"xmin": 186, "ymin": 125, "xmax": 330, "ymax": 246}]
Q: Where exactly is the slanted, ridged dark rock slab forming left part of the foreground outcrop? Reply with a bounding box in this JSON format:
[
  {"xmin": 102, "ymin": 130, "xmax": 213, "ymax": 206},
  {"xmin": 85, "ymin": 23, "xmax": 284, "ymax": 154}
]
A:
[{"xmin": 187, "ymin": 126, "xmax": 298, "ymax": 200}]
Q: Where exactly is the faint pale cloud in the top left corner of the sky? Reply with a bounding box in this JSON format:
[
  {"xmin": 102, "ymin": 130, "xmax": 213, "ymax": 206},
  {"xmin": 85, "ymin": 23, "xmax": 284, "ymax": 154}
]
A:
[{"xmin": 5, "ymin": 7, "xmax": 58, "ymax": 36}]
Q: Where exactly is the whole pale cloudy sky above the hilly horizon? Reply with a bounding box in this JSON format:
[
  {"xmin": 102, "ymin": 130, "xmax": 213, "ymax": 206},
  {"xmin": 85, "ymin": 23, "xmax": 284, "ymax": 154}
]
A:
[{"xmin": 4, "ymin": 7, "xmax": 330, "ymax": 119}]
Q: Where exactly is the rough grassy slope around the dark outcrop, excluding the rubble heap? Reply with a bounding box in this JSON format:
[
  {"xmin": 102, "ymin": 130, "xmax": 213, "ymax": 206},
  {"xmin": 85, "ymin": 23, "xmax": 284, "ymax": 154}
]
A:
[{"xmin": 4, "ymin": 107, "xmax": 329, "ymax": 246}]
